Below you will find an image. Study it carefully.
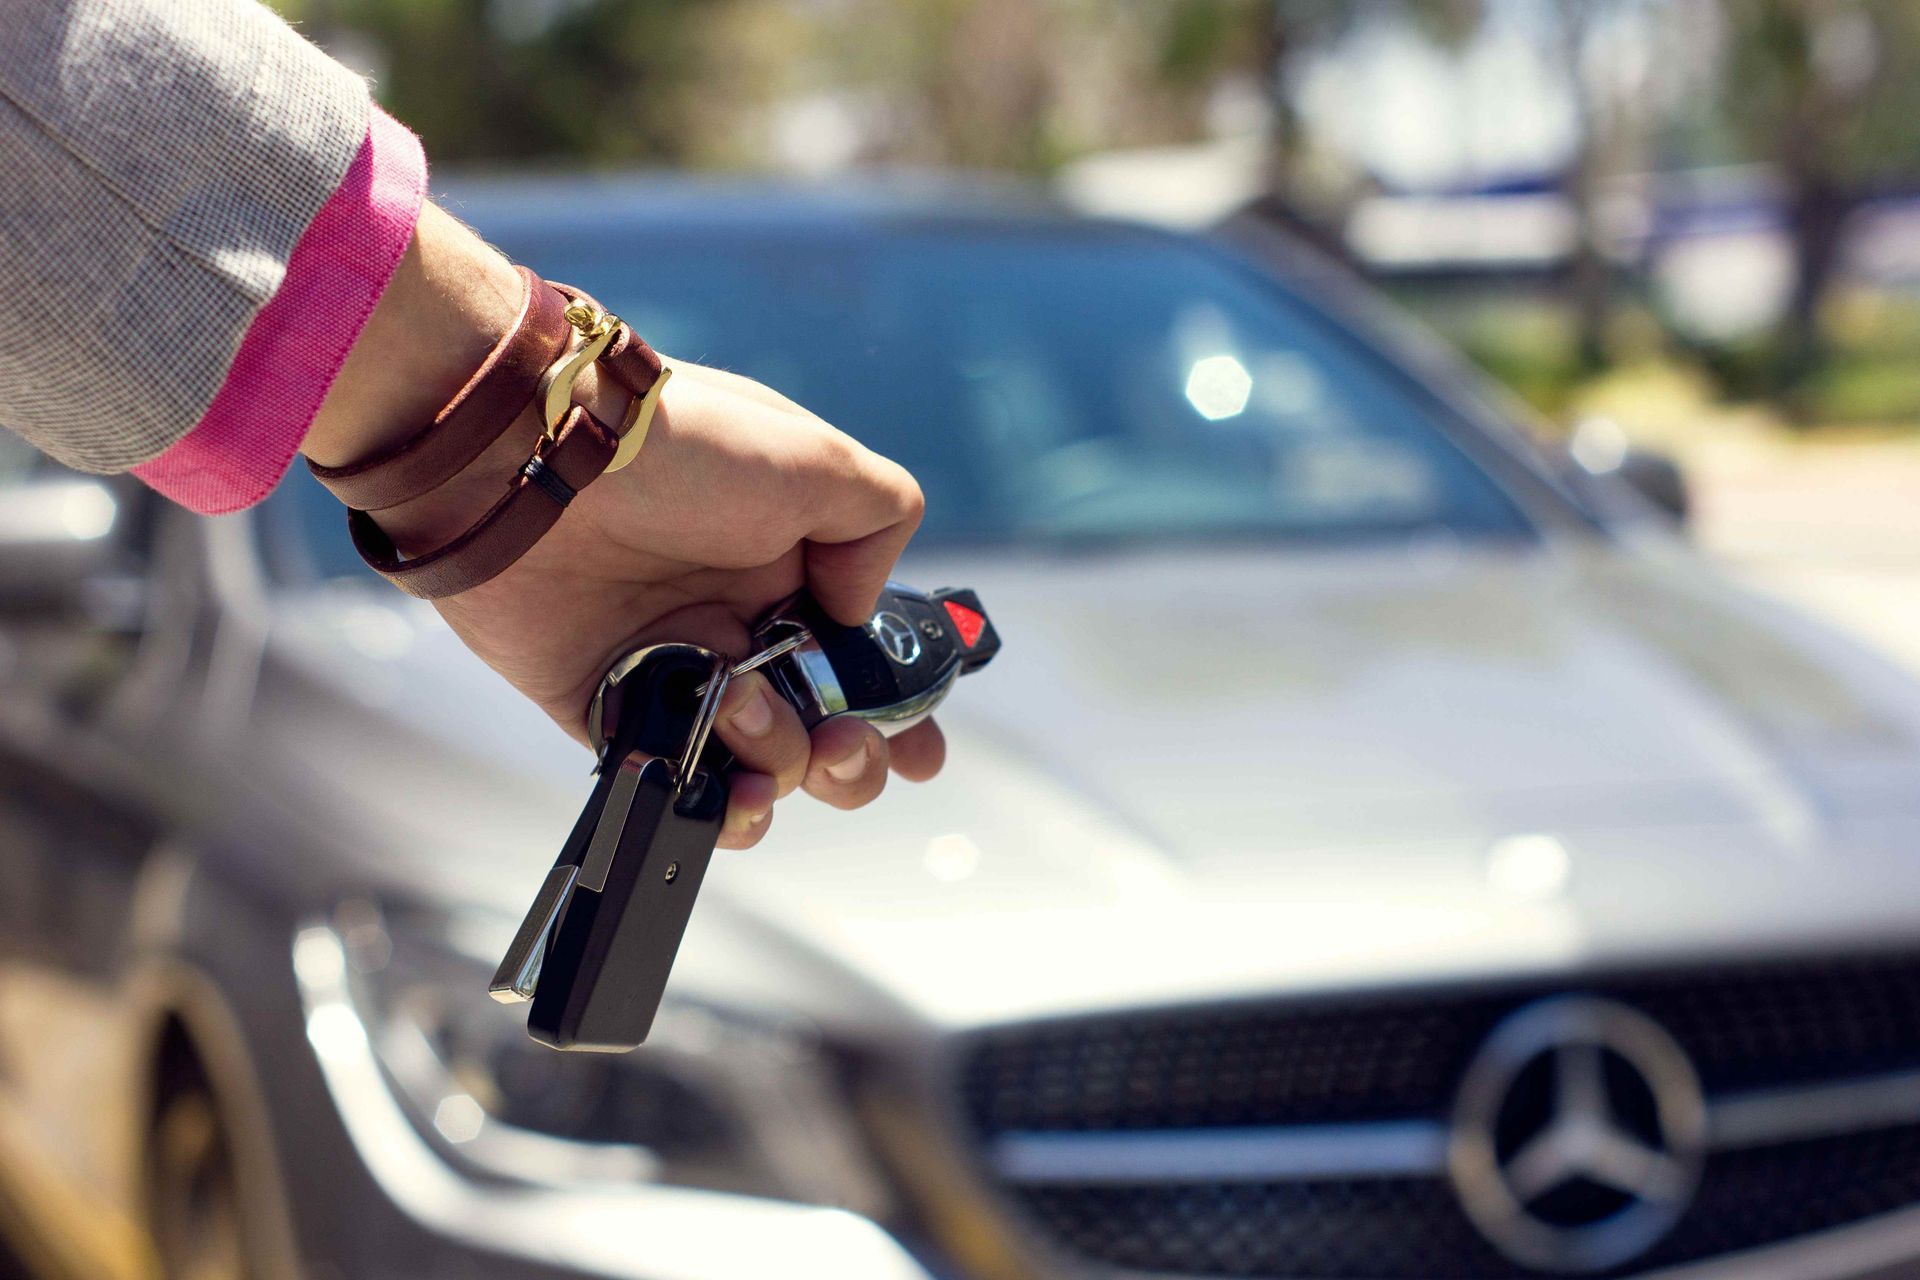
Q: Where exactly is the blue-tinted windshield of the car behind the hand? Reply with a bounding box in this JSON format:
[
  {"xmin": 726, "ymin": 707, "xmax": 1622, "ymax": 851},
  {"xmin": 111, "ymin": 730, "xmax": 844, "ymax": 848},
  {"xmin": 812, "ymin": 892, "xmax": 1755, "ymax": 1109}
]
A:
[{"xmin": 266, "ymin": 225, "xmax": 1528, "ymax": 568}]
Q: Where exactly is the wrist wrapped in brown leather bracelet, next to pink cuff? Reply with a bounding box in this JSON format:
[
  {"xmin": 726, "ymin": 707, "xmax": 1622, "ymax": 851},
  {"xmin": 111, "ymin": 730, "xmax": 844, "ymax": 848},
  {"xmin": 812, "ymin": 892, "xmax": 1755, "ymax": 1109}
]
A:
[{"xmin": 301, "ymin": 222, "xmax": 666, "ymax": 583}]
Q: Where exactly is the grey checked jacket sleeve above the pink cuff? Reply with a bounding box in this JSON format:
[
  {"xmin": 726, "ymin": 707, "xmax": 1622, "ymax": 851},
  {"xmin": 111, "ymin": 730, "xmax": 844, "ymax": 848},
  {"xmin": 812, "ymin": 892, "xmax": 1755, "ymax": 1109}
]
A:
[{"xmin": 0, "ymin": 0, "xmax": 369, "ymax": 472}]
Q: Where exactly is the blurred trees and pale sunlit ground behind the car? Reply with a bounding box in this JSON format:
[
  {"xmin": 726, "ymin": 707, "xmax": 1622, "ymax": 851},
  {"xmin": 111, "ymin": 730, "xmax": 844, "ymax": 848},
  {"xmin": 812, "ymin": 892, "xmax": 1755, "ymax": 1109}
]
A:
[{"xmin": 275, "ymin": 0, "xmax": 1920, "ymax": 671}]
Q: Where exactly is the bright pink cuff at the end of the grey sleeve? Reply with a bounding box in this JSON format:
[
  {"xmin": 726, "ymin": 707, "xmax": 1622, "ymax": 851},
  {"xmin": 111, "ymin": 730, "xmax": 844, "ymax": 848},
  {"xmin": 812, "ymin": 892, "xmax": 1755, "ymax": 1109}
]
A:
[{"xmin": 132, "ymin": 107, "xmax": 426, "ymax": 516}]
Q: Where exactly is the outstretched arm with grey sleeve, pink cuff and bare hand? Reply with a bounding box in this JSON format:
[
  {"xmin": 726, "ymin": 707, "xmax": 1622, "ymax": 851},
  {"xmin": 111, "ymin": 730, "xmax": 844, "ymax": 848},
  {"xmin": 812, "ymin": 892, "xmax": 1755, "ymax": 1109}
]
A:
[{"xmin": 0, "ymin": 0, "xmax": 943, "ymax": 846}]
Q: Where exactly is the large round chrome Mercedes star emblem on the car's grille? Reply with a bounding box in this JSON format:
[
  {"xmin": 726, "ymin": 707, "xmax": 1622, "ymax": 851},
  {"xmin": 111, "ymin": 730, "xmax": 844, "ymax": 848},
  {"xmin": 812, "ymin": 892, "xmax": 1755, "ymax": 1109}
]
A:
[{"xmin": 1448, "ymin": 996, "xmax": 1707, "ymax": 1272}]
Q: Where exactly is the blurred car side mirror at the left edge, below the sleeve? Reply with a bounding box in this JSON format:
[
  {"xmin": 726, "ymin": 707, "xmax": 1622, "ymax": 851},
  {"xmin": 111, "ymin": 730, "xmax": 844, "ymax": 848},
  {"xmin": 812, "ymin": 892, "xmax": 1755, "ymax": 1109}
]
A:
[{"xmin": 0, "ymin": 472, "xmax": 127, "ymax": 614}]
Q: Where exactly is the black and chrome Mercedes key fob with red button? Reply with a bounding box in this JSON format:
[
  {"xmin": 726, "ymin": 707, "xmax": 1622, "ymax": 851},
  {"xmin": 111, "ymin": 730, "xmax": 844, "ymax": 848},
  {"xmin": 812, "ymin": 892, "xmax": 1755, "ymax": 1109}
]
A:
[{"xmin": 753, "ymin": 581, "xmax": 1000, "ymax": 733}]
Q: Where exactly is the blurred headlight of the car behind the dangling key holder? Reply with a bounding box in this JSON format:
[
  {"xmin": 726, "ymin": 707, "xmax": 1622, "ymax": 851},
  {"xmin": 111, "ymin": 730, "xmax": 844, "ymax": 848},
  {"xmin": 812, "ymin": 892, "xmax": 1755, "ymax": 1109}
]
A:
[{"xmin": 296, "ymin": 904, "xmax": 887, "ymax": 1217}]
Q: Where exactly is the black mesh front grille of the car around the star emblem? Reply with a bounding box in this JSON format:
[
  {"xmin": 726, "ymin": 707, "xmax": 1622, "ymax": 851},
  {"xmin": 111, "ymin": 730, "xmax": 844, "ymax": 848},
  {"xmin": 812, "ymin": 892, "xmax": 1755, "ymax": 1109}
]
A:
[{"xmin": 962, "ymin": 956, "xmax": 1920, "ymax": 1280}]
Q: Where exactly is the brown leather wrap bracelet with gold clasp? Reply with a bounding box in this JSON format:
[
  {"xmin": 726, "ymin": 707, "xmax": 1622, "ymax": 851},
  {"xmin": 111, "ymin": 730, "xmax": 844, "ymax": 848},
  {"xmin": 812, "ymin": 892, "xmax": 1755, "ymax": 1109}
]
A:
[{"xmin": 313, "ymin": 269, "xmax": 672, "ymax": 599}]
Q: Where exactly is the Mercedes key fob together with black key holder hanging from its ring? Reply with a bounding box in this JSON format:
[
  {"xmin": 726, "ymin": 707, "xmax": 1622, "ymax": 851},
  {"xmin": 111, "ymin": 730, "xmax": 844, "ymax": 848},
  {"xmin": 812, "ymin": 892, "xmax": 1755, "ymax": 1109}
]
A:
[{"xmin": 490, "ymin": 583, "xmax": 1000, "ymax": 1052}]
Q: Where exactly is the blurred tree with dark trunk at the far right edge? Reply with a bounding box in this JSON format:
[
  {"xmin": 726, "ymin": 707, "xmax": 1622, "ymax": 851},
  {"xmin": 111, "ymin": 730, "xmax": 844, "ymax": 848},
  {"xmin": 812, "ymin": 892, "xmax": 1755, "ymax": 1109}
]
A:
[{"xmin": 1720, "ymin": 0, "xmax": 1920, "ymax": 391}]
